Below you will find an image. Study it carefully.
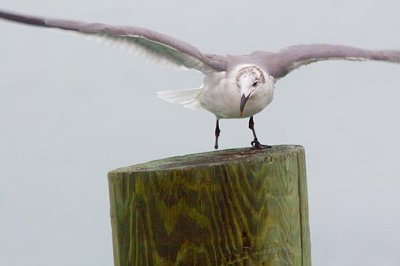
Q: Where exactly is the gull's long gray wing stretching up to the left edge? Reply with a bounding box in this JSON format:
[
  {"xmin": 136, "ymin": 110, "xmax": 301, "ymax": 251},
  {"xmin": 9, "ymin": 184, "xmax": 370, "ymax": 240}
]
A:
[{"xmin": 0, "ymin": 10, "xmax": 226, "ymax": 73}]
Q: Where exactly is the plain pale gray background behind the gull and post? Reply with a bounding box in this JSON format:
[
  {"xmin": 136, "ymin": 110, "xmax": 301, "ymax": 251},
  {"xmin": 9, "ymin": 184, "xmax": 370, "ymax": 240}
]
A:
[{"xmin": 0, "ymin": 0, "xmax": 400, "ymax": 266}]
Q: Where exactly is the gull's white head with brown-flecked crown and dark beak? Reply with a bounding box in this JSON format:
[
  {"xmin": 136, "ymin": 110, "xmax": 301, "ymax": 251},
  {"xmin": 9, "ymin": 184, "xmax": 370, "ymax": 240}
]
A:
[{"xmin": 236, "ymin": 65, "xmax": 267, "ymax": 116}]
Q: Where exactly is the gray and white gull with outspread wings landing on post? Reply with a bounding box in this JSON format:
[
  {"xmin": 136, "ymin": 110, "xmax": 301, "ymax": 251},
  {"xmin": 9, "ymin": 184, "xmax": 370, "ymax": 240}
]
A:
[{"xmin": 0, "ymin": 10, "xmax": 400, "ymax": 149}]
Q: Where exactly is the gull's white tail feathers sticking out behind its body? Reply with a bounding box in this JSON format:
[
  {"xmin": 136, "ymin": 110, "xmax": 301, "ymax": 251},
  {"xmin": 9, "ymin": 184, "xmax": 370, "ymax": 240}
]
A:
[{"xmin": 157, "ymin": 87, "xmax": 203, "ymax": 109}]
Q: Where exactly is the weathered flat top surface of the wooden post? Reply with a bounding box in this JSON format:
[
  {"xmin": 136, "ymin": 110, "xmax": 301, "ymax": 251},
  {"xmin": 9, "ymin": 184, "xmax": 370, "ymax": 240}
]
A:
[{"xmin": 110, "ymin": 145, "xmax": 304, "ymax": 173}]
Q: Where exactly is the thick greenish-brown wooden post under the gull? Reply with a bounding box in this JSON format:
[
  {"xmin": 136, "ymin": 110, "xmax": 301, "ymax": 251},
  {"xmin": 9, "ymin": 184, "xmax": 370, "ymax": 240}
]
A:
[{"xmin": 108, "ymin": 146, "xmax": 311, "ymax": 266}]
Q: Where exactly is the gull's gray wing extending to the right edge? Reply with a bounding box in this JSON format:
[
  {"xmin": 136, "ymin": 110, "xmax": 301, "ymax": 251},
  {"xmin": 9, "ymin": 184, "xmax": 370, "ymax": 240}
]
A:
[{"xmin": 264, "ymin": 44, "xmax": 400, "ymax": 79}]
